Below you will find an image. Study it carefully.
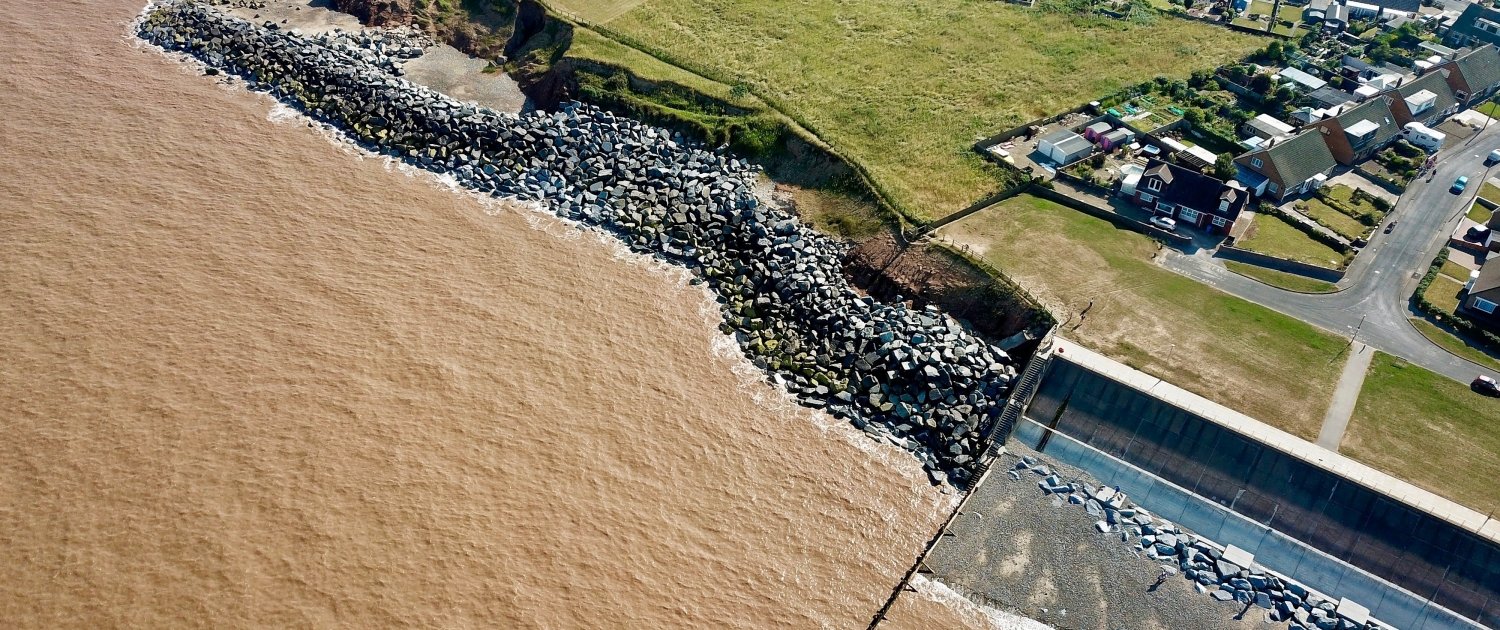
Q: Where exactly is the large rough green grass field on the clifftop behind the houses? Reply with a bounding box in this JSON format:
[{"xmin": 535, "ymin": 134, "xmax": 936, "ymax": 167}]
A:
[{"xmin": 549, "ymin": 0, "xmax": 1266, "ymax": 218}]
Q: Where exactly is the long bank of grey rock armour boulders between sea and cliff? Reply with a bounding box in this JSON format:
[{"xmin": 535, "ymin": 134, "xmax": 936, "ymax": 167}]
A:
[{"xmin": 140, "ymin": 2, "xmax": 1016, "ymax": 485}]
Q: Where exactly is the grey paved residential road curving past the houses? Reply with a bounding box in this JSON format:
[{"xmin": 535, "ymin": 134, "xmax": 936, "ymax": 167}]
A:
[{"xmin": 1161, "ymin": 125, "xmax": 1500, "ymax": 383}]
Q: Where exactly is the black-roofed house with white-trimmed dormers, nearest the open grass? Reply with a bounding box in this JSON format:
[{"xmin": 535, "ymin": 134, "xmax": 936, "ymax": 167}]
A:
[{"xmin": 1131, "ymin": 159, "xmax": 1250, "ymax": 234}]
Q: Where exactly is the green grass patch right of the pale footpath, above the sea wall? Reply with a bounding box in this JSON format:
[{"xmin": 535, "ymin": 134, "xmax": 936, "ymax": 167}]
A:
[{"xmin": 1340, "ymin": 353, "xmax": 1500, "ymax": 513}]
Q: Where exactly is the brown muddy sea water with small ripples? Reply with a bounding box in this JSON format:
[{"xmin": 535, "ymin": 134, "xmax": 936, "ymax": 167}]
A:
[{"xmin": 0, "ymin": 0, "xmax": 1002, "ymax": 629}]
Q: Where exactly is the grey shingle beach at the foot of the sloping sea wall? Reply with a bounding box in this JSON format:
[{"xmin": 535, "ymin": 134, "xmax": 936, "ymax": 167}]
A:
[{"xmin": 926, "ymin": 444, "xmax": 1287, "ymax": 630}]
